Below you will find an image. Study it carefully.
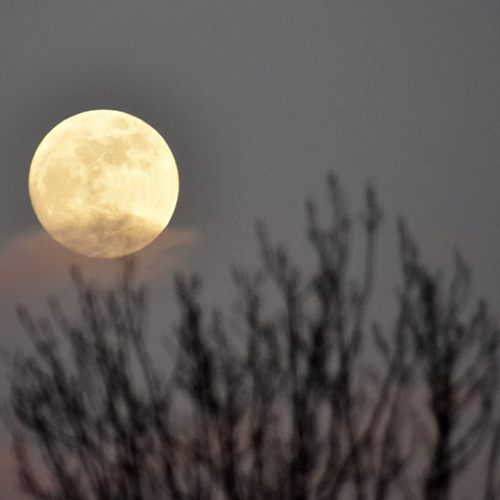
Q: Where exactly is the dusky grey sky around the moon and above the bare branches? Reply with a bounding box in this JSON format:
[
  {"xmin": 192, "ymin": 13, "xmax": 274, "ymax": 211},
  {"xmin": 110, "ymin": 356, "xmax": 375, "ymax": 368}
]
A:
[{"xmin": 0, "ymin": 0, "xmax": 500, "ymax": 498}]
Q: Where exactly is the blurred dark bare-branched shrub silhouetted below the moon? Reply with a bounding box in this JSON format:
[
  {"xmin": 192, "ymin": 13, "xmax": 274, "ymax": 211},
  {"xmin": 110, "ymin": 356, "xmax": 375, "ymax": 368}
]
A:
[{"xmin": 6, "ymin": 175, "xmax": 500, "ymax": 500}]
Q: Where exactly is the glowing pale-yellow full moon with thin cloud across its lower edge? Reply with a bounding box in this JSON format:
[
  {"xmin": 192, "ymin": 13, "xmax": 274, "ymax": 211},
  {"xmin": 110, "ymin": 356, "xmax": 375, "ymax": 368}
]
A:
[{"xmin": 29, "ymin": 109, "xmax": 179, "ymax": 258}]
